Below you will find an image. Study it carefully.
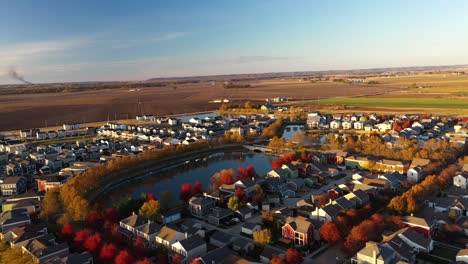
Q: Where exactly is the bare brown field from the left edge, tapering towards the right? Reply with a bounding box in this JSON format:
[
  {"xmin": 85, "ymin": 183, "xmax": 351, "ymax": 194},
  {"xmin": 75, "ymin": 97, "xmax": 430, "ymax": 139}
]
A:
[{"xmin": 0, "ymin": 81, "xmax": 397, "ymax": 130}]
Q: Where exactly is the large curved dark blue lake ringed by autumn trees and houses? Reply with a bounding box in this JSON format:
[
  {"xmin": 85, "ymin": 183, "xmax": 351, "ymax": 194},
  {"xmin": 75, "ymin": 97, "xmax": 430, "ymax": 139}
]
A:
[{"xmin": 109, "ymin": 152, "xmax": 275, "ymax": 203}]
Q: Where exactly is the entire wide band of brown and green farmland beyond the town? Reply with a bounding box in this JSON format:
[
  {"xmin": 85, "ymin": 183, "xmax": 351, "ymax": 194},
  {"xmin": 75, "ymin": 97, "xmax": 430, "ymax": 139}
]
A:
[{"xmin": 0, "ymin": 74, "xmax": 468, "ymax": 131}]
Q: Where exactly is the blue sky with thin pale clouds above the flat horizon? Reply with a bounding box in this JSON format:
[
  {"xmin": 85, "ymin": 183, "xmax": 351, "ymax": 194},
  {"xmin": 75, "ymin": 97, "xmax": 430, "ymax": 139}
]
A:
[{"xmin": 0, "ymin": 0, "xmax": 468, "ymax": 83}]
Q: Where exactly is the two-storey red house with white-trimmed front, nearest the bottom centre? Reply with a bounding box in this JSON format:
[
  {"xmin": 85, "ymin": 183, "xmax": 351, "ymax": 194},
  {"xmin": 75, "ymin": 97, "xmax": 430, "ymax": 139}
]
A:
[{"xmin": 281, "ymin": 216, "xmax": 314, "ymax": 247}]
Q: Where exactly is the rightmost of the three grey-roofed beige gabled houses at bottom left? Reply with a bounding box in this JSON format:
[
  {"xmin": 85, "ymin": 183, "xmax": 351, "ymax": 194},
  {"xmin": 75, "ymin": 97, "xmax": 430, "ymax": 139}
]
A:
[{"xmin": 171, "ymin": 235, "xmax": 207, "ymax": 263}]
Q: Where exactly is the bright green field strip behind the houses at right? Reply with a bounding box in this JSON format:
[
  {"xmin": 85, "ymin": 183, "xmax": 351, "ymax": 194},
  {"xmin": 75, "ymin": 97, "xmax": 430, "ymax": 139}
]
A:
[{"xmin": 310, "ymin": 97, "xmax": 468, "ymax": 109}]
